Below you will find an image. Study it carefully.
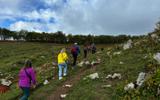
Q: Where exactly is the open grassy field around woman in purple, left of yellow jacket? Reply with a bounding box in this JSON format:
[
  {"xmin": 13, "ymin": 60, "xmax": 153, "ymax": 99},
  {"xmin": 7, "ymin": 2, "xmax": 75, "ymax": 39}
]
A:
[{"xmin": 0, "ymin": 42, "xmax": 64, "ymax": 100}]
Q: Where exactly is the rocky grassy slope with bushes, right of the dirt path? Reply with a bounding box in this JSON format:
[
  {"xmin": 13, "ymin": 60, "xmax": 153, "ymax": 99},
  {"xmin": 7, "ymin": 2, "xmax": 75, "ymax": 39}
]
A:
[{"xmin": 66, "ymin": 31, "xmax": 160, "ymax": 100}]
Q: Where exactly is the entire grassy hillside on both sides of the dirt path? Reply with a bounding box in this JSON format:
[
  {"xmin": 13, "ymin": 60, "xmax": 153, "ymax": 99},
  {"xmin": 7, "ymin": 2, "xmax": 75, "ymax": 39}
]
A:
[{"xmin": 0, "ymin": 32, "xmax": 160, "ymax": 100}]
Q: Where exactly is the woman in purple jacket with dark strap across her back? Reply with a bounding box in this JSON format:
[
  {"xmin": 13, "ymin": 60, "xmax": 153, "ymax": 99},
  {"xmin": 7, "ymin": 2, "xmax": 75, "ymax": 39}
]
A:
[{"xmin": 18, "ymin": 60, "xmax": 36, "ymax": 100}]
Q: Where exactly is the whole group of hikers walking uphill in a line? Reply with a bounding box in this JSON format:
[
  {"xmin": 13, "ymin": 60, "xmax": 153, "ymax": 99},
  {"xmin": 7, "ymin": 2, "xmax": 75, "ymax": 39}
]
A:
[{"xmin": 18, "ymin": 43, "xmax": 96, "ymax": 100}]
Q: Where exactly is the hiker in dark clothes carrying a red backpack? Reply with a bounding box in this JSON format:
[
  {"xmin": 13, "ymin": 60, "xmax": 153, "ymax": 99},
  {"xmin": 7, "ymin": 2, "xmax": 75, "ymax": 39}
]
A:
[{"xmin": 71, "ymin": 43, "xmax": 80, "ymax": 67}]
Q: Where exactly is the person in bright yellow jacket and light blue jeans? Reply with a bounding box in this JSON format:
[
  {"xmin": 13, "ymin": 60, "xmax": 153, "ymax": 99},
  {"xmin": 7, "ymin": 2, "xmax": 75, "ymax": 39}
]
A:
[{"xmin": 58, "ymin": 48, "xmax": 68, "ymax": 80}]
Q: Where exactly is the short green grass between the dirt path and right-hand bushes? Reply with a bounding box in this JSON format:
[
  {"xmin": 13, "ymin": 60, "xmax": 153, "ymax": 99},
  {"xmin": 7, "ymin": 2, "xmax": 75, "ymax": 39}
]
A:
[{"xmin": 66, "ymin": 38, "xmax": 160, "ymax": 100}]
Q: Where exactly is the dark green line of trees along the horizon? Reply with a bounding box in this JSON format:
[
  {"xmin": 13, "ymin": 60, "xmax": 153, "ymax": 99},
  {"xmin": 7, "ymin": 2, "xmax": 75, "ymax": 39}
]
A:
[{"xmin": 0, "ymin": 28, "xmax": 142, "ymax": 44}]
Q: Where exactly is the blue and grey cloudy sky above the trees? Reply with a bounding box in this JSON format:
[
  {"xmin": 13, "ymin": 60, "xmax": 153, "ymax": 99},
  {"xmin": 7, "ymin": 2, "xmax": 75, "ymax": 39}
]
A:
[{"xmin": 0, "ymin": 0, "xmax": 160, "ymax": 35}]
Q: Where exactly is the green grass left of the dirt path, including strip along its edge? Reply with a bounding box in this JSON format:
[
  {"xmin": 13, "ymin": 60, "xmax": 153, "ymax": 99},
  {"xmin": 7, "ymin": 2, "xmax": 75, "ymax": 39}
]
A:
[{"xmin": 0, "ymin": 42, "xmax": 109, "ymax": 100}]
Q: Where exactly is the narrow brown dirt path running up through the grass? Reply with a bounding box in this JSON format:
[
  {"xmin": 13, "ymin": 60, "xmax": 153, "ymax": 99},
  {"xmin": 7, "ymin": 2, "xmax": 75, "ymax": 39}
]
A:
[{"xmin": 47, "ymin": 66, "xmax": 96, "ymax": 100}]
